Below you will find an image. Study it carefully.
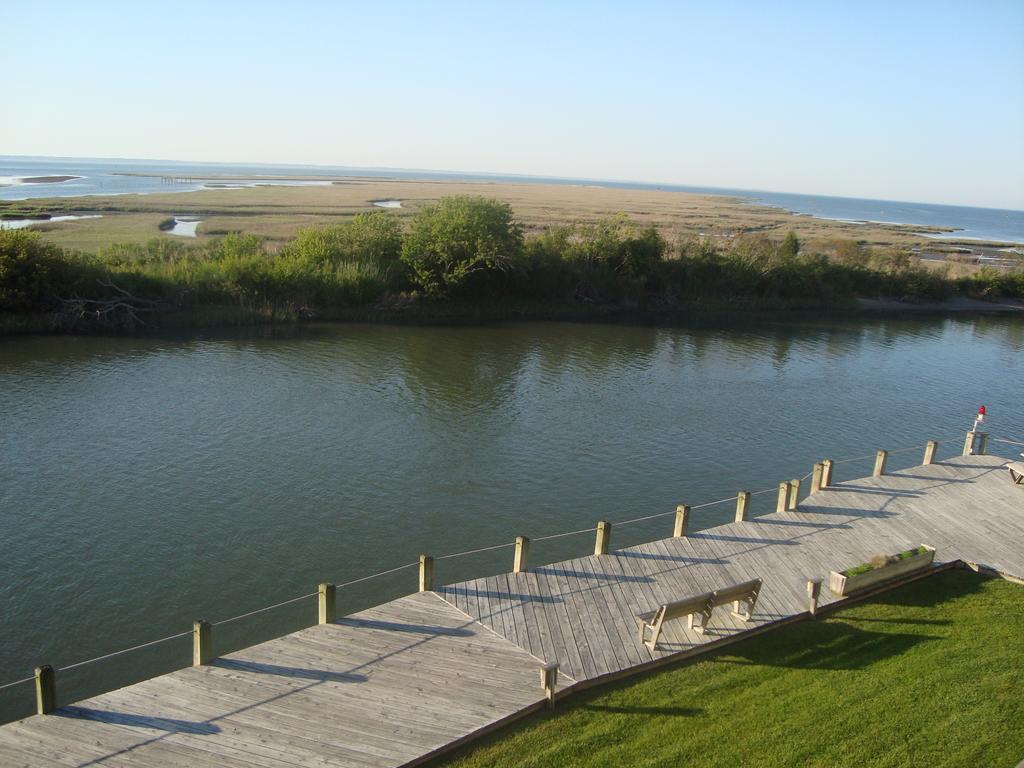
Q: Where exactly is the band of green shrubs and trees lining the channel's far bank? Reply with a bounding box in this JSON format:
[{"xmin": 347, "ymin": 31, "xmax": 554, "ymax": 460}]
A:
[{"xmin": 0, "ymin": 198, "xmax": 1024, "ymax": 331}]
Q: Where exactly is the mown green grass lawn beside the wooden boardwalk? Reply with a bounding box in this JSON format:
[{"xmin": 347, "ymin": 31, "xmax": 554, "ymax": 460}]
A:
[{"xmin": 432, "ymin": 570, "xmax": 1024, "ymax": 768}]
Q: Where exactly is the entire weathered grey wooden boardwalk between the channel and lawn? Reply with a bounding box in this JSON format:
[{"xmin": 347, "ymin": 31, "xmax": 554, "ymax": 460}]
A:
[{"xmin": 0, "ymin": 456, "xmax": 1024, "ymax": 768}]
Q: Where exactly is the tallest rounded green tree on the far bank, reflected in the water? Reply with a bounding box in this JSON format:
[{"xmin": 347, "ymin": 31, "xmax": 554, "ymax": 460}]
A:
[{"xmin": 401, "ymin": 197, "xmax": 523, "ymax": 296}]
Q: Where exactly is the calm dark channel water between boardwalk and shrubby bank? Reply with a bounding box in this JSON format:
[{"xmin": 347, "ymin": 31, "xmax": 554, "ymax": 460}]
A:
[{"xmin": 0, "ymin": 317, "xmax": 1024, "ymax": 720}]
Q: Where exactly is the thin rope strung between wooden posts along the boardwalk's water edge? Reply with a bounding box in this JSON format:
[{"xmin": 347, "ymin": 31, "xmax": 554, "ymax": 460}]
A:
[{"xmin": 0, "ymin": 430, "xmax": 983, "ymax": 708}]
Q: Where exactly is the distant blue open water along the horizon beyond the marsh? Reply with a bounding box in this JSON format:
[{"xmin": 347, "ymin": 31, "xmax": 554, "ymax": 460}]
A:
[{"xmin": 0, "ymin": 156, "xmax": 1024, "ymax": 243}]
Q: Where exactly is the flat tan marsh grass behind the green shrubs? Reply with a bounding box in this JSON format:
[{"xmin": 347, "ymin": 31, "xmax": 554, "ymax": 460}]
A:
[{"xmin": 0, "ymin": 178, "xmax": 1007, "ymax": 252}]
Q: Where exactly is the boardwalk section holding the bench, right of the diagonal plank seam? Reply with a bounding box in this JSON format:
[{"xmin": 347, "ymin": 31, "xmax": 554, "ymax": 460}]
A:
[{"xmin": 438, "ymin": 456, "xmax": 1024, "ymax": 682}]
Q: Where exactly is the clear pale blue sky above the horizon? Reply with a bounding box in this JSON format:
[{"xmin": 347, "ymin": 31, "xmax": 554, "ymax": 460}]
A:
[{"xmin": 0, "ymin": 0, "xmax": 1024, "ymax": 210}]
